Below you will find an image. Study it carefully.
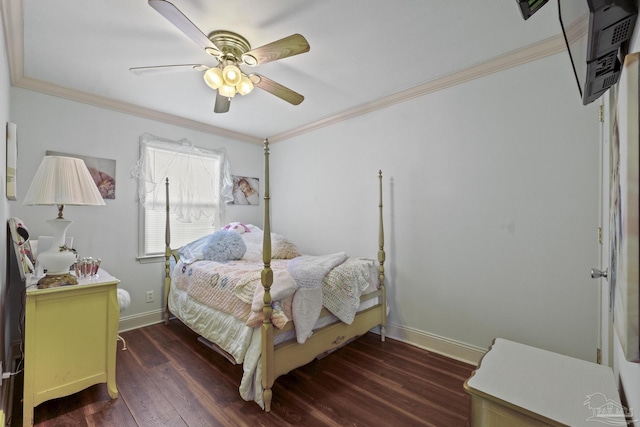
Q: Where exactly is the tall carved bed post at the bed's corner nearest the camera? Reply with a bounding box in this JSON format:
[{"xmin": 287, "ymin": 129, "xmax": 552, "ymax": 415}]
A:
[{"xmin": 261, "ymin": 139, "xmax": 275, "ymax": 412}]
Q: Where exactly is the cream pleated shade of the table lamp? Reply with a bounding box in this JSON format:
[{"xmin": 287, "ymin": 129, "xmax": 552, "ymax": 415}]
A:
[{"xmin": 23, "ymin": 156, "xmax": 105, "ymax": 214}]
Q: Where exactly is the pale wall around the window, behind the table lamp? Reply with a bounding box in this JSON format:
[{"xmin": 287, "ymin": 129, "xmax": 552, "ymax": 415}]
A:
[{"xmin": 10, "ymin": 88, "xmax": 263, "ymax": 327}]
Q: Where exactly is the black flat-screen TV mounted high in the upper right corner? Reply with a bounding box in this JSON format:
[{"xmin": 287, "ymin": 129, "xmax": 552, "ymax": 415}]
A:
[{"xmin": 558, "ymin": 0, "xmax": 637, "ymax": 105}]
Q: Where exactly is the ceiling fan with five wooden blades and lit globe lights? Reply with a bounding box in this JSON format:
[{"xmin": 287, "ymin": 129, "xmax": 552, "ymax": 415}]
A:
[{"xmin": 129, "ymin": 0, "xmax": 310, "ymax": 113}]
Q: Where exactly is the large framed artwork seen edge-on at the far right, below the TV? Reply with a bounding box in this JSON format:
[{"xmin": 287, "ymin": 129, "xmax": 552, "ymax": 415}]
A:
[{"xmin": 609, "ymin": 53, "xmax": 640, "ymax": 362}]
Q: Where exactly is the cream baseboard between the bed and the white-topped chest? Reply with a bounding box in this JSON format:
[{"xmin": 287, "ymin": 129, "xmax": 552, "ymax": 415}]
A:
[{"xmin": 386, "ymin": 324, "xmax": 487, "ymax": 366}]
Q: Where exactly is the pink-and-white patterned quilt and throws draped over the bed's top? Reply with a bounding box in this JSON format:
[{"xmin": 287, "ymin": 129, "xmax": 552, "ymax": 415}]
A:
[{"xmin": 172, "ymin": 252, "xmax": 376, "ymax": 344}]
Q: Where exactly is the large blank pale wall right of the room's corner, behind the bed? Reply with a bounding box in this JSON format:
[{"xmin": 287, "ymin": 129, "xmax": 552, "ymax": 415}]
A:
[{"xmin": 271, "ymin": 50, "xmax": 599, "ymax": 360}]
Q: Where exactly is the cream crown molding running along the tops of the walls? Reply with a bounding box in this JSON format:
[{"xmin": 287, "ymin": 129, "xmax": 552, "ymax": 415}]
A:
[{"xmin": 2, "ymin": 0, "xmax": 568, "ymax": 145}]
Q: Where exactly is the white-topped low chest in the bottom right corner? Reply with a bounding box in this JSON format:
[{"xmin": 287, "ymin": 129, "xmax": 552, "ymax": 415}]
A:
[{"xmin": 464, "ymin": 338, "xmax": 626, "ymax": 427}]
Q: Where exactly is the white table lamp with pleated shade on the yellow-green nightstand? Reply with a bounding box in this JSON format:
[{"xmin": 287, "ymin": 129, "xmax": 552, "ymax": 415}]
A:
[{"xmin": 23, "ymin": 156, "xmax": 105, "ymax": 288}]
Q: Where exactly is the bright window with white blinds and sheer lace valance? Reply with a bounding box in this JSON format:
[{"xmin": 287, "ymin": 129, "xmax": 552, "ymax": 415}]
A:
[{"xmin": 134, "ymin": 134, "xmax": 232, "ymax": 259}]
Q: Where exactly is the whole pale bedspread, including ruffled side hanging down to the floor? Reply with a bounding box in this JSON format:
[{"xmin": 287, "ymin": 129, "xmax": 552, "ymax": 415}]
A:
[{"xmin": 169, "ymin": 253, "xmax": 378, "ymax": 408}]
